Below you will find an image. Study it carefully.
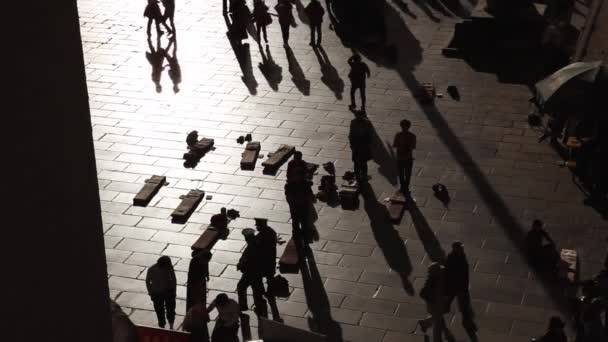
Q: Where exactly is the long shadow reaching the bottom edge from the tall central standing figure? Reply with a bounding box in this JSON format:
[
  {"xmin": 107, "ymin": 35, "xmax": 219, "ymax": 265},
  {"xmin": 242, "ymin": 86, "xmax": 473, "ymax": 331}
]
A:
[{"xmin": 297, "ymin": 242, "xmax": 343, "ymax": 342}]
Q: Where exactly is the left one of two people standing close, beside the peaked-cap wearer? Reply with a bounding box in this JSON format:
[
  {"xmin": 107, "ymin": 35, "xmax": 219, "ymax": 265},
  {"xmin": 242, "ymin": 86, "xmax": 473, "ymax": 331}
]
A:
[{"xmin": 236, "ymin": 228, "xmax": 268, "ymax": 317}]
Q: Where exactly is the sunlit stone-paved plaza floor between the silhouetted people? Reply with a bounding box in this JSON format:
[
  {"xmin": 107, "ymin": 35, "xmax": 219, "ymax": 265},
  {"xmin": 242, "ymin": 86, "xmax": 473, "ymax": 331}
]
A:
[{"xmin": 78, "ymin": 0, "xmax": 608, "ymax": 342}]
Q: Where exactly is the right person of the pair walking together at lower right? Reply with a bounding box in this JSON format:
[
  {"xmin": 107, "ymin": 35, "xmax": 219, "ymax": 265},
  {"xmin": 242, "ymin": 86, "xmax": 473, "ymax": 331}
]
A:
[{"xmin": 445, "ymin": 241, "xmax": 477, "ymax": 341}]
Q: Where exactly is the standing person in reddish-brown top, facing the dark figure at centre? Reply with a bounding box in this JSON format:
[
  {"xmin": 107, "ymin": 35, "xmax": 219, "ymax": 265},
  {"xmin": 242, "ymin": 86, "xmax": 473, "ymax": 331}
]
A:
[{"xmin": 393, "ymin": 119, "xmax": 416, "ymax": 194}]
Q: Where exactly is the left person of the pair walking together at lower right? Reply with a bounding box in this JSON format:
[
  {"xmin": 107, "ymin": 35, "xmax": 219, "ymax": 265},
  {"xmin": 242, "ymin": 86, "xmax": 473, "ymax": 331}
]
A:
[{"xmin": 418, "ymin": 262, "xmax": 454, "ymax": 342}]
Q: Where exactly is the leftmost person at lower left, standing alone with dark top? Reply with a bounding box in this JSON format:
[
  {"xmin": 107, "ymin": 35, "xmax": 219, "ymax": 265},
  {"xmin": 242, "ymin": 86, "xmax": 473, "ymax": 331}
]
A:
[{"xmin": 146, "ymin": 255, "xmax": 177, "ymax": 330}]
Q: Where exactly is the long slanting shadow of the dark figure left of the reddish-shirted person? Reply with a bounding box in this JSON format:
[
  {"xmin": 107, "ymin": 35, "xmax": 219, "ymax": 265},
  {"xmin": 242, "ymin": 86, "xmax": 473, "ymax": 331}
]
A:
[{"xmin": 361, "ymin": 183, "xmax": 414, "ymax": 295}]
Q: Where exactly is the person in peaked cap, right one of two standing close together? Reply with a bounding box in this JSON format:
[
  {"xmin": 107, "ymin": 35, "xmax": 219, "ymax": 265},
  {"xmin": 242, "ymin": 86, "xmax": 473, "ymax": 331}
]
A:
[{"xmin": 255, "ymin": 218, "xmax": 282, "ymax": 322}]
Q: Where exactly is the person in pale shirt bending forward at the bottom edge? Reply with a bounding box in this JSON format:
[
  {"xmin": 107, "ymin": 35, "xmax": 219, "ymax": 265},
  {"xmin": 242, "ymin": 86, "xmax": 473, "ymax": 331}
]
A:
[{"xmin": 207, "ymin": 293, "xmax": 240, "ymax": 342}]
